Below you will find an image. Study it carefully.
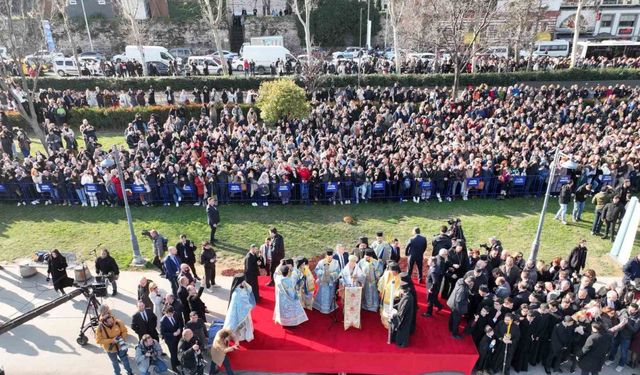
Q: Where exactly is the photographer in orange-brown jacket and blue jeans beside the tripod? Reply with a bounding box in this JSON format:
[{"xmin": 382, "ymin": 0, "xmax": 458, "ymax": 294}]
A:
[{"xmin": 96, "ymin": 312, "xmax": 133, "ymax": 375}]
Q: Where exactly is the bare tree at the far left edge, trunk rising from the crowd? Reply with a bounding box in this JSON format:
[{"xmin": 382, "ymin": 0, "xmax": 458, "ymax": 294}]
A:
[{"xmin": 0, "ymin": 0, "xmax": 49, "ymax": 154}]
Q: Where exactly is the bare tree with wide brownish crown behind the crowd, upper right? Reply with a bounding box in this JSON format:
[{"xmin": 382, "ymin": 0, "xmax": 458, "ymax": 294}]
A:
[{"xmin": 424, "ymin": 0, "xmax": 498, "ymax": 97}]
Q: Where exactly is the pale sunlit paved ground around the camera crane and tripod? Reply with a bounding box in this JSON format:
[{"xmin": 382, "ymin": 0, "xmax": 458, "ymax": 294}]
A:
[{"xmin": 0, "ymin": 266, "xmax": 632, "ymax": 375}]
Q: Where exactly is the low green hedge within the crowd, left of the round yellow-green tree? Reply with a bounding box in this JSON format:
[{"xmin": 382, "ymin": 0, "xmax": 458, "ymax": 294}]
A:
[{"xmin": 7, "ymin": 104, "xmax": 260, "ymax": 131}]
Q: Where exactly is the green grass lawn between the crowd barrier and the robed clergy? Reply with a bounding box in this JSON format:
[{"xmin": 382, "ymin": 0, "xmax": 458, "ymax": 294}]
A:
[{"xmin": 0, "ymin": 199, "xmax": 621, "ymax": 275}]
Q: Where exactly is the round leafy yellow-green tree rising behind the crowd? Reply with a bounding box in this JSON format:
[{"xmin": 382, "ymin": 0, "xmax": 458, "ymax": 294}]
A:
[{"xmin": 256, "ymin": 79, "xmax": 310, "ymax": 123}]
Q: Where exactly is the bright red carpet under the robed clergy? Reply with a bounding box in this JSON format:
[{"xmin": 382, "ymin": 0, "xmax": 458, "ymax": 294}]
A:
[{"xmin": 229, "ymin": 277, "xmax": 478, "ymax": 375}]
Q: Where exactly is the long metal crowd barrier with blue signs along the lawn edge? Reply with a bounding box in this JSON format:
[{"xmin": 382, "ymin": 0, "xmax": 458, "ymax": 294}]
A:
[{"xmin": 0, "ymin": 175, "xmax": 613, "ymax": 205}]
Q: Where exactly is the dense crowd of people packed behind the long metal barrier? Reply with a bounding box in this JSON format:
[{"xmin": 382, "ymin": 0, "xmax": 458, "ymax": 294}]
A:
[{"xmin": 0, "ymin": 84, "xmax": 640, "ymax": 214}]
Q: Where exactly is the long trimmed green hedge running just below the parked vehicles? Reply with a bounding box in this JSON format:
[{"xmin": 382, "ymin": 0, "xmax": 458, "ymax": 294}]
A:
[{"xmin": 27, "ymin": 69, "xmax": 640, "ymax": 91}]
